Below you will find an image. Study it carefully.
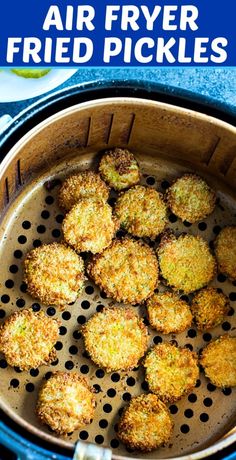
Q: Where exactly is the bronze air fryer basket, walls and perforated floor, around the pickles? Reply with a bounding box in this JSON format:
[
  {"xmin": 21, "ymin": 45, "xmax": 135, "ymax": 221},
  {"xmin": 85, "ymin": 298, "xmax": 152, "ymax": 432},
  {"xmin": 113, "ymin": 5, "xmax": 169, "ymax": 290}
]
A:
[{"xmin": 0, "ymin": 97, "xmax": 236, "ymax": 459}]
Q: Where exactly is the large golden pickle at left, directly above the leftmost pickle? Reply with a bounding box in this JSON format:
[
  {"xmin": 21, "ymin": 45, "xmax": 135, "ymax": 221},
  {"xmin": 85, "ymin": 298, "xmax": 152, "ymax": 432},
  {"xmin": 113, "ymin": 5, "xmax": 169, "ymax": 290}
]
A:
[{"xmin": 24, "ymin": 243, "xmax": 84, "ymax": 306}]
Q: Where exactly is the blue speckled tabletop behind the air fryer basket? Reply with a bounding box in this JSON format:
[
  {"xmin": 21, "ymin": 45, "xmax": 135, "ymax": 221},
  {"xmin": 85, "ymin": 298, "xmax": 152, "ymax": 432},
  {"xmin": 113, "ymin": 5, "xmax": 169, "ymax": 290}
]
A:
[{"xmin": 0, "ymin": 67, "xmax": 236, "ymax": 116}]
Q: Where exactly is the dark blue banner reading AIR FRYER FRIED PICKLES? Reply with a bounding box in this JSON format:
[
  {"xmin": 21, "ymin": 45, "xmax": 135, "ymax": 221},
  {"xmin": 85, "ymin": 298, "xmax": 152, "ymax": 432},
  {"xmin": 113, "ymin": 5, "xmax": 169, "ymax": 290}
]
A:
[{"xmin": 0, "ymin": 0, "xmax": 236, "ymax": 67}]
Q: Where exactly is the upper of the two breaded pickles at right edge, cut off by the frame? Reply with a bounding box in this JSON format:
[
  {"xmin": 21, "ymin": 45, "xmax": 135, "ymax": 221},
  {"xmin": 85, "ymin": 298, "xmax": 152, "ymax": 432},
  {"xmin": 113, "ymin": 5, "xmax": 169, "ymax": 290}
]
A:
[{"xmin": 215, "ymin": 225, "xmax": 236, "ymax": 281}]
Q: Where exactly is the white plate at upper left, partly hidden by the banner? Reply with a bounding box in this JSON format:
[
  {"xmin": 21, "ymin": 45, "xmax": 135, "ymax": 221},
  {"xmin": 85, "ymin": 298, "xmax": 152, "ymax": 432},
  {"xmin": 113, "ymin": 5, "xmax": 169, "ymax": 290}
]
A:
[{"xmin": 0, "ymin": 69, "xmax": 78, "ymax": 102}]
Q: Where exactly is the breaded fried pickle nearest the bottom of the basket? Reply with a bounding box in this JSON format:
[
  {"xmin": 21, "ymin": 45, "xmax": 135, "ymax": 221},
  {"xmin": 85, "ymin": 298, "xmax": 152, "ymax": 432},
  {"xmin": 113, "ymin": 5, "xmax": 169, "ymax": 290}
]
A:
[{"xmin": 117, "ymin": 393, "xmax": 174, "ymax": 452}]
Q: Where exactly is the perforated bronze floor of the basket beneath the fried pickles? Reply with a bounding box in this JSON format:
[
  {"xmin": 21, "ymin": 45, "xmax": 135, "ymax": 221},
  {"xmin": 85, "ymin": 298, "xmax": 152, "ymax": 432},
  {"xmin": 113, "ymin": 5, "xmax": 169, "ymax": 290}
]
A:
[{"xmin": 0, "ymin": 95, "xmax": 236, "ymax": 458}]
